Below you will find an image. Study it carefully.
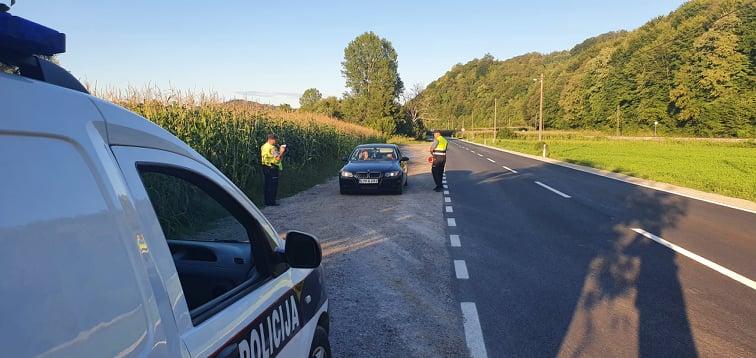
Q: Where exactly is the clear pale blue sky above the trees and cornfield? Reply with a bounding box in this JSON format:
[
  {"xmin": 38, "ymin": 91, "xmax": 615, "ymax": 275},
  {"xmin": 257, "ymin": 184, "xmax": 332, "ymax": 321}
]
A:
[{"xmin": 11, "ymin": 0, "xmax": 683, "ymax": 106}]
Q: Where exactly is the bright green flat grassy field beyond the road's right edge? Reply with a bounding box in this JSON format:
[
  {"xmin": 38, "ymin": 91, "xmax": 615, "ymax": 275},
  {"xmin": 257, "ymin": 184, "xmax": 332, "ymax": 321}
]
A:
[{"xmin": 466, "ymin": 138, "xmax": 756, "ymax": 201}]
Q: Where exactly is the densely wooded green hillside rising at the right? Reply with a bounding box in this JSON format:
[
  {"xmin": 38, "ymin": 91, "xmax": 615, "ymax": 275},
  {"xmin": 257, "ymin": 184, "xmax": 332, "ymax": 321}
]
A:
[{"xmin": 416, "ymin": 0, "xmax": 756, "ymax": 137}]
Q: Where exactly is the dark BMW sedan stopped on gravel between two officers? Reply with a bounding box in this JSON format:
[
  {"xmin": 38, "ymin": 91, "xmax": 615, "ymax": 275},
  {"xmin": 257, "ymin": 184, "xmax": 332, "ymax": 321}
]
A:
[{"xmin": 339, "ymin": 144, "xmax": 409, "ymax": 194}]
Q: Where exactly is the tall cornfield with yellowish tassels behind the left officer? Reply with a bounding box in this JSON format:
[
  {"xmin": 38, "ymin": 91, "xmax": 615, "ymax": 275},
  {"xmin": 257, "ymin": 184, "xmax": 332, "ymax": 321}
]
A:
[{"xmin": 93, "ymin": 85, "xmax": 386, "ymax": 205}]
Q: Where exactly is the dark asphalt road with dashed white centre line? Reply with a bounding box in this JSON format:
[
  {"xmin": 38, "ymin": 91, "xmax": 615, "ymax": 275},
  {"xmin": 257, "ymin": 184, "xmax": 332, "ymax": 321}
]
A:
[{"xmin": 442, "ymin": 141, "xmax": 756, "ymax": 357}]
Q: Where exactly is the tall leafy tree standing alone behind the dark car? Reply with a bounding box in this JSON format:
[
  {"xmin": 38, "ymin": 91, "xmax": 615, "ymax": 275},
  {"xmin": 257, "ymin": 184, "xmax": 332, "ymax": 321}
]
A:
[{"xmin": 341, "ymin": 32, "xmax": 404, "ymax": 134}]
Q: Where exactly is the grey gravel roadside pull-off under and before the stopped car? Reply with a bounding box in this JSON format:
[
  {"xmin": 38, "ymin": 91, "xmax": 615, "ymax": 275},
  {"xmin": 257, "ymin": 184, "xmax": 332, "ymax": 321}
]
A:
[{"xmin": 263, "ymin": 144, "xmax": 468, "ymax": 357}]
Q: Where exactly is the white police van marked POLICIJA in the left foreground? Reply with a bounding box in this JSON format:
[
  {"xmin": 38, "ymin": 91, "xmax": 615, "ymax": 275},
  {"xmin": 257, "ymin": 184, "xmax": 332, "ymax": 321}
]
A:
[{"xmin": 0, "ymin": 4, "xmax": 330, "ymax": 357}]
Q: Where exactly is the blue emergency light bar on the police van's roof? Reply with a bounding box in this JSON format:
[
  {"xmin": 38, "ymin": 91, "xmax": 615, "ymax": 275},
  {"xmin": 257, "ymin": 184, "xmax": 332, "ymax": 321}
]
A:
[{"xmin": 0, "ymin": 12, "xmax": 66, "ymax": 56}]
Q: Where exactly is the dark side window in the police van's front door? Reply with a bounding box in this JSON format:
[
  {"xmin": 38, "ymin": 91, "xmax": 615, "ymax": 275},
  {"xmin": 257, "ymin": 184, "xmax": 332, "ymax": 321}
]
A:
[{"xmin": 139, "ymin": 166, "xmax": 268, "ymax": 323}]
